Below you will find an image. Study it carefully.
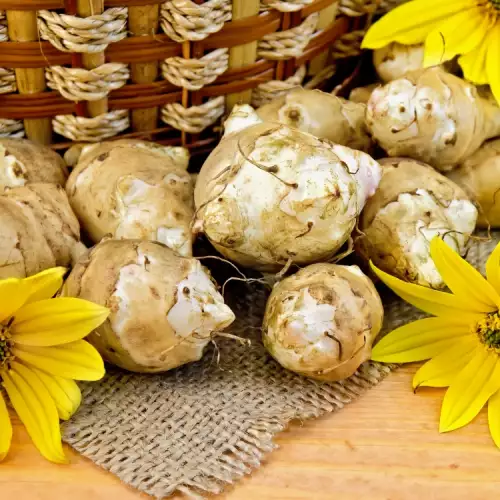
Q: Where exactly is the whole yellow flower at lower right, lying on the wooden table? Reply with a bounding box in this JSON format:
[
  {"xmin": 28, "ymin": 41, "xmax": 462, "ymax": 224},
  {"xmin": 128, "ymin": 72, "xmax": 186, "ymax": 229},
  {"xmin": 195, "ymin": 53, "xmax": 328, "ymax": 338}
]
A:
[{"xmin": 372, "ymin": 237, "xmax": 500, "ymax": 447}]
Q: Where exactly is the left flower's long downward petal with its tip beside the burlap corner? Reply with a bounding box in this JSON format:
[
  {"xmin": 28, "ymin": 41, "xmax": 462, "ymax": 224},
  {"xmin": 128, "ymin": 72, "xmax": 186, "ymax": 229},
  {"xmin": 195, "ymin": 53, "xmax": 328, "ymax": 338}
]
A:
[{"xmin": 2, "ymin": 362, "xmax": 67, "ymax": 463}]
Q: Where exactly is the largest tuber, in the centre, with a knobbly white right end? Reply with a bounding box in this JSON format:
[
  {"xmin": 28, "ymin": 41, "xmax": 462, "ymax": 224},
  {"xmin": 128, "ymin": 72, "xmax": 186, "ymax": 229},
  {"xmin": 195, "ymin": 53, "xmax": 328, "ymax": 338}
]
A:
[{"xmin": 194, "ymin": 105, "xmax": 380, "ymax": 272}]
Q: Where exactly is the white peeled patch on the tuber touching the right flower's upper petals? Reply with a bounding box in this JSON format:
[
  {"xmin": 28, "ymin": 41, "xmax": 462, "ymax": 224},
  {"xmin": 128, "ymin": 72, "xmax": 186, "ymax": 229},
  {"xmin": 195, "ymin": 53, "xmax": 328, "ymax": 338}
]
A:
[{"xmin": 377, "ymin": 189, "xmax": 477, "ymax": 288}]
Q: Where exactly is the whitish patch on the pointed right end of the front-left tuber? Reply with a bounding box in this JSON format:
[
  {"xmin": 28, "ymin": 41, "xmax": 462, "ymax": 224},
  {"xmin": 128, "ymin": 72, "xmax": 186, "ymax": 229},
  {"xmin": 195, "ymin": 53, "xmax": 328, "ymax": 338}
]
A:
[{"xmin": 167, "ymin": 262, "xmax": 235, "ymax": 339}]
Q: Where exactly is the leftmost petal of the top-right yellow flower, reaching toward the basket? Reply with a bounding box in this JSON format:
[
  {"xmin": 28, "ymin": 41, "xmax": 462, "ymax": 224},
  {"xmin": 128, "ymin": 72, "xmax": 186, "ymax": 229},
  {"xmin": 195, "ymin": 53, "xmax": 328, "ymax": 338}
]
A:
[{"xmin": 362, "ymin": 0, "xmax": 475, "ymax": 49}]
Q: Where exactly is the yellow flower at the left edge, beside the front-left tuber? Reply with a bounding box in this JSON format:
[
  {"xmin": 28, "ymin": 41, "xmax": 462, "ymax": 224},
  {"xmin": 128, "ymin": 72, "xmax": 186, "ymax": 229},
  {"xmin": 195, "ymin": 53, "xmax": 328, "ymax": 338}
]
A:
[{"xmin": 0, "ymin": 268, "xmax": 109, "ymax": 463}]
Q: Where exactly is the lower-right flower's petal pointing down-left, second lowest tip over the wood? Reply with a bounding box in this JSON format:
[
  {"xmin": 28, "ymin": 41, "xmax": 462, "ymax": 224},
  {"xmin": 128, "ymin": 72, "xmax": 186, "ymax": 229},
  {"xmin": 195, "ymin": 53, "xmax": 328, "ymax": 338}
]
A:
[{"xmin": 439, "ymin": 348, "xmax": 500, "ymax": 432}]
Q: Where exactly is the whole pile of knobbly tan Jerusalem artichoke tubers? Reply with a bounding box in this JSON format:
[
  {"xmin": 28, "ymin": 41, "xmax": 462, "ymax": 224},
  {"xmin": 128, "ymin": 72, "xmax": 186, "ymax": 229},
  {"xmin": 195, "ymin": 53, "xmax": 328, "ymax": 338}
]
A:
[{"xmin": 0, "ymin": 44, "xmax": 500, "ymax": 381}]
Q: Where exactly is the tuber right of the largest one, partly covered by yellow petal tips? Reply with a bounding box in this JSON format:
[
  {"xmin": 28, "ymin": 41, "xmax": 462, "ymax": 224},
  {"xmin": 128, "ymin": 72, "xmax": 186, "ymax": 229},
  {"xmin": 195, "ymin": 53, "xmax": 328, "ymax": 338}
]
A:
[{"xmin": 354, "ymin": 158, "xmax": 477, "ymax": 288}]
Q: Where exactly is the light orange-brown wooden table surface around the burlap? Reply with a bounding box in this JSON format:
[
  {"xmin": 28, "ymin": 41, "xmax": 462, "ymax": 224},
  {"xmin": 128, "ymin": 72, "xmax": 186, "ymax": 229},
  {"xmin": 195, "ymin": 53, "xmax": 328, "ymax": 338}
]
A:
[{"xmin": 0, "ymin": 367, "xmax": 500, "ymax": 500}]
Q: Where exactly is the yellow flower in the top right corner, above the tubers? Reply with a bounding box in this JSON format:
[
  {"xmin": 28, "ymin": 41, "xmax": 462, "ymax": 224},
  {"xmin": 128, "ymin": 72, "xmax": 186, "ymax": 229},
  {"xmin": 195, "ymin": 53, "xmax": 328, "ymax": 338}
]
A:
[{"xmin": 362, "ymin": 0, "xmax": 500, "ymax": 103}]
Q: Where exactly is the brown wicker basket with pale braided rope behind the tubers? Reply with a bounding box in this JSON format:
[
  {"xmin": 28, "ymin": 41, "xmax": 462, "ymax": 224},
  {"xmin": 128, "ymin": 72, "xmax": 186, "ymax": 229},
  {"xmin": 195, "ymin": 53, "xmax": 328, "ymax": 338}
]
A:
[{"xmin": 0, "ymin": 0, "xmax": 401, "ymax": 158}]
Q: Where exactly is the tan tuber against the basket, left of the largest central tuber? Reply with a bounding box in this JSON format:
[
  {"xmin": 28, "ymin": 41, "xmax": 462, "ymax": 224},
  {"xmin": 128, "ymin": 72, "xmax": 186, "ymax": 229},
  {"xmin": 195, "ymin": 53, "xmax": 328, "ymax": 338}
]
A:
[{"xmin": 66, "ymin": 139, "xmax": 194, "ymax": 256}]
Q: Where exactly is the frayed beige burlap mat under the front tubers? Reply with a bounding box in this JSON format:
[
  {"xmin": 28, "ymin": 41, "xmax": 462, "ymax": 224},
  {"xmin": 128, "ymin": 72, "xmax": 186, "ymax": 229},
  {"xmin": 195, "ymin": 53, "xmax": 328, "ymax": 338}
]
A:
[{"xmin": 60, "ymin": 235, "xmax": 498, "ymax": 498}]
